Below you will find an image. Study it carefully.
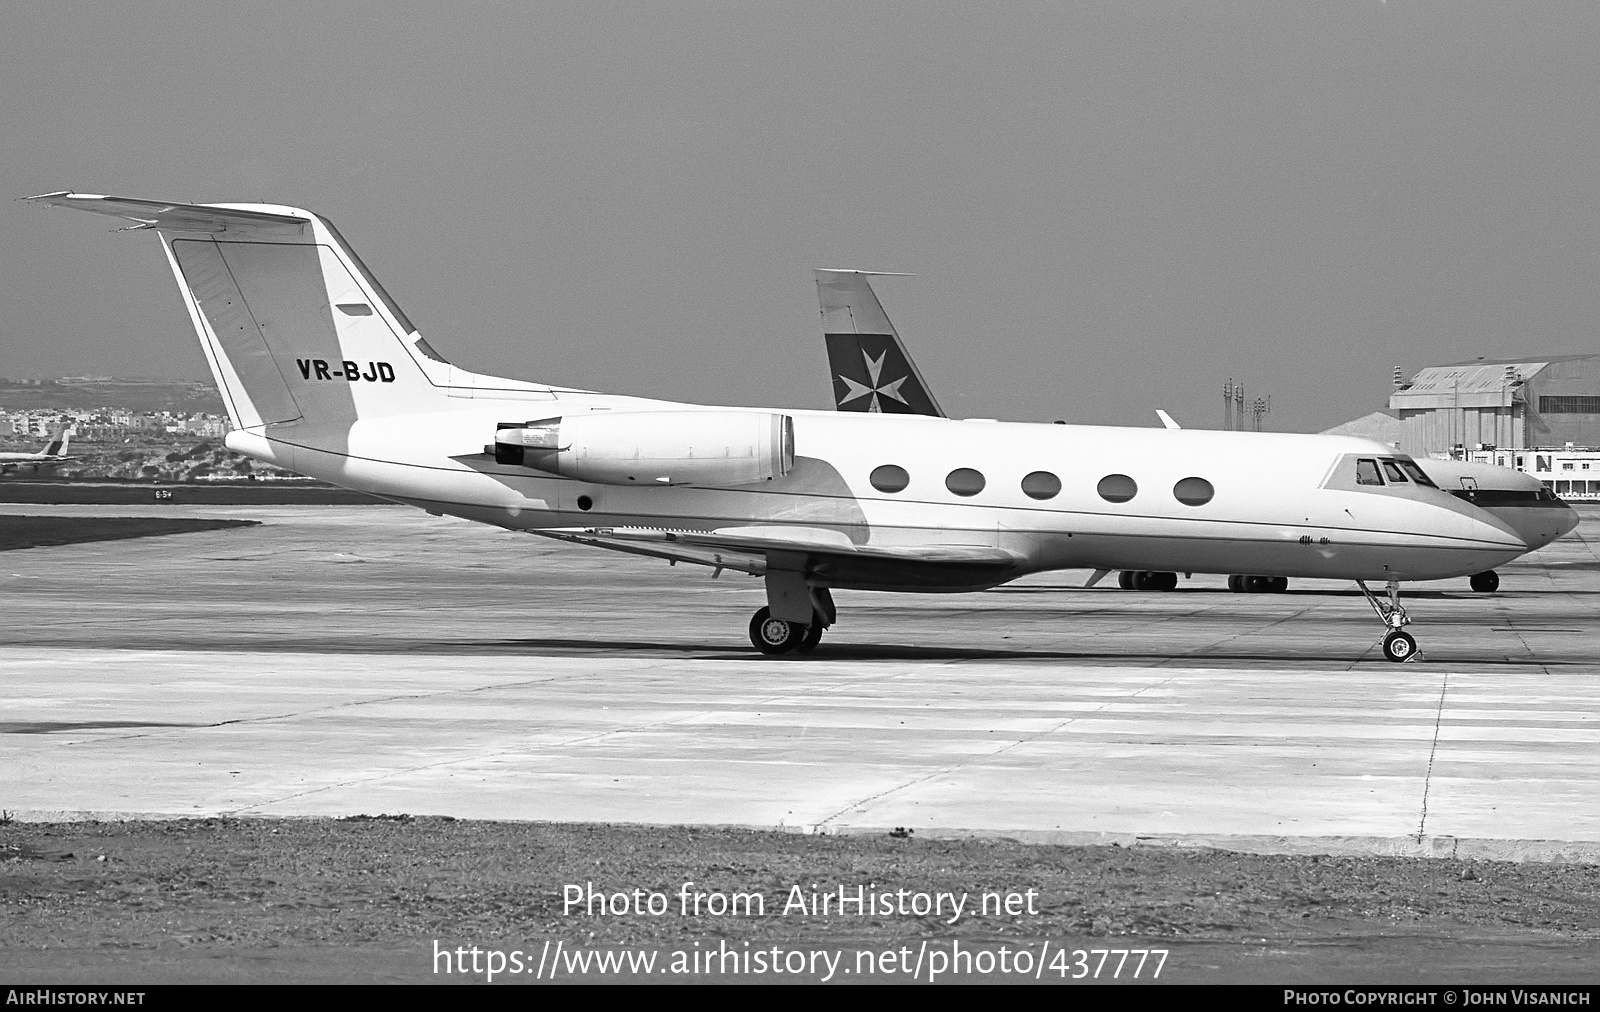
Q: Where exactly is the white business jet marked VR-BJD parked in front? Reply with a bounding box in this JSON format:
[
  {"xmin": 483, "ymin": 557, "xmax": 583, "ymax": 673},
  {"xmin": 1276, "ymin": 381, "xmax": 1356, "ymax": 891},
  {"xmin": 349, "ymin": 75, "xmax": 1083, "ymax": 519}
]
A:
[{"xmin": 30, "ymin": 192, "xmax": 1548, "ymax": 661}]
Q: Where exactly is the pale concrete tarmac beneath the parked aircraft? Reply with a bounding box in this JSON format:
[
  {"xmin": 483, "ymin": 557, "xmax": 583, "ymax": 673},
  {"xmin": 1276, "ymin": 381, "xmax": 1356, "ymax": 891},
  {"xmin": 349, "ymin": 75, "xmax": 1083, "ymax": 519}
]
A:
[{"xmin": 0, "ymin": 504, "xmax": 1600, "ymax": 861}]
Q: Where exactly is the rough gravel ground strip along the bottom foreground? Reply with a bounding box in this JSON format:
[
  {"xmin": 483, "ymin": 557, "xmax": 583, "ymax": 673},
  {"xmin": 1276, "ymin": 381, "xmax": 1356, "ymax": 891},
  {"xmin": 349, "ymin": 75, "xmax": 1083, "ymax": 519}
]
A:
[{"xmin": 0, "ymin": 817, "xmax": 1600, "ymax": 980}]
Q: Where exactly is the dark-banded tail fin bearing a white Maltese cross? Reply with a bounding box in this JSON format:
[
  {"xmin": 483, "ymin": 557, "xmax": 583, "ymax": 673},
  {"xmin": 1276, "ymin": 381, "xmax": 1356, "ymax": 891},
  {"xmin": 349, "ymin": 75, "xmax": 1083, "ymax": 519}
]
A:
[{"xmin": 816, "ymin": 271, "xmax": 944, "ymax": 418}]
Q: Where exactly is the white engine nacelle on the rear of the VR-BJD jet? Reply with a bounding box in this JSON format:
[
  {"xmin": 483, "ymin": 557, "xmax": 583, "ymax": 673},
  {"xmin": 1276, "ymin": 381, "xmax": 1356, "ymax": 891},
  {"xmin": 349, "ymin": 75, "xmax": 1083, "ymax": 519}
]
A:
[{"xmin": 494, "ymin": 412, "xmax": 795, "ymax": 485}]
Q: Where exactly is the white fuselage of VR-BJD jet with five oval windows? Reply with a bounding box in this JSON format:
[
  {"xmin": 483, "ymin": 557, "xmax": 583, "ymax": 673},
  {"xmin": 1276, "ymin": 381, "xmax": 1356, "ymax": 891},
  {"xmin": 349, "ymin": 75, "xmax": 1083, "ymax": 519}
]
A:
[{"xmin": 229, "ymin": 396, "xmax": 1526, "ymax": 591}]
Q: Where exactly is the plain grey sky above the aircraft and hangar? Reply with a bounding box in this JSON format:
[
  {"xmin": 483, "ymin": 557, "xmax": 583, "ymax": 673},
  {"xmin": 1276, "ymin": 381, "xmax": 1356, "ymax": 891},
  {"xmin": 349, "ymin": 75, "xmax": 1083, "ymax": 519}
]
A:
[{"xmin": 0, "ymin": 0, "xmax": 1600, "ymax": 431}]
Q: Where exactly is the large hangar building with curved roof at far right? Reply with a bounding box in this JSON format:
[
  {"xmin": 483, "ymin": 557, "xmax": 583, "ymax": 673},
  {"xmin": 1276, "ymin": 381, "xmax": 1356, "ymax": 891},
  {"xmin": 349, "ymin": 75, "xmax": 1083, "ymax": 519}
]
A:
[{"xmin": 1389, "ymin": 354, "xmax": 1600, "ymax": 456}]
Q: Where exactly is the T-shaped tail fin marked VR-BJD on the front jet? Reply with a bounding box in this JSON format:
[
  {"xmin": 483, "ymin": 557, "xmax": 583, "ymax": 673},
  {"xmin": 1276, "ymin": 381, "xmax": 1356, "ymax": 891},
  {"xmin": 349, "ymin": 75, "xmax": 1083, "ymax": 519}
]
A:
[{"xmin": 29, "ymin": 192, "xmax": 459, "ymax": 429}]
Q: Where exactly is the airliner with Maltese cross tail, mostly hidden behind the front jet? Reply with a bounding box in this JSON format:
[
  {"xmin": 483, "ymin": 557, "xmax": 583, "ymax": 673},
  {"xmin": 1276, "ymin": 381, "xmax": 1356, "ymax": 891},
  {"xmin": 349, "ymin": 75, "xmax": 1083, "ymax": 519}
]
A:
[{"xmin": 816, "ymin": 271, "xmax": 1579, "ymax": 592}]
